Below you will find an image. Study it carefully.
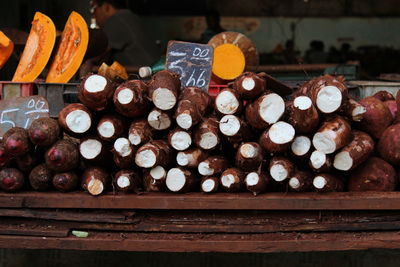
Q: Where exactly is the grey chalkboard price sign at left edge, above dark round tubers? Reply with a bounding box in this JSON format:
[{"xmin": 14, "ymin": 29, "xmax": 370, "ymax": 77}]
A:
[{"xmin": 0, "ymin": 96, "xmax": 49, "ymax": 138}]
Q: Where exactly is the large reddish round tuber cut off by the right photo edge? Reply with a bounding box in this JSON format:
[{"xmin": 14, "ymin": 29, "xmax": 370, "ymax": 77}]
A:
[{"xmin": 377, "ymin": 124, "xmax": 400, "ymax": 166}]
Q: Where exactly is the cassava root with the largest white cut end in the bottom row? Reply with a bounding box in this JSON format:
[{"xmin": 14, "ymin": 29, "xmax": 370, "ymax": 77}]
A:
[{"xmin": 166, "ymin": 168, "xmax": 197, "ymax": 193}]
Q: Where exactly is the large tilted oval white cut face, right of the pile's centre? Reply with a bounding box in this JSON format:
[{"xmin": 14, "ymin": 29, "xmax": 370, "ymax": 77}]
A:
[{"xmin": 259, "ymin": 93, "xmax": 285, "ymax": 124}]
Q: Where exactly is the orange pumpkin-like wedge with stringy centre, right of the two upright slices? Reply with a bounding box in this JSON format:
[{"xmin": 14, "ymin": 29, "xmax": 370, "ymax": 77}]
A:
[{"xmin": 46, "ymin": 11, "xmax": 89, "ymax": 83}]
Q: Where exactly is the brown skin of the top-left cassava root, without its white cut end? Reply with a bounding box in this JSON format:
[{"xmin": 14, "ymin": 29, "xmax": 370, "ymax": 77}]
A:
[{"xmin": 78, "ymin": 74, "xmax": 115, "ymax": 111}]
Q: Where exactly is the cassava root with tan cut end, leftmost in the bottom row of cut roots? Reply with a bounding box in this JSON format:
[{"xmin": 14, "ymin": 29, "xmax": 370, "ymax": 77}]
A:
[{"xmin": 81, "ymin": 167, "xmax": 111, "ymax": 195}]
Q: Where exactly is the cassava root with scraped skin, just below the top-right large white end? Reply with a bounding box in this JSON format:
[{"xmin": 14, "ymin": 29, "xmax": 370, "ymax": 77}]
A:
[{"xmin": 313, "ymin": 116, "xmax": 352, "ymax": 154}]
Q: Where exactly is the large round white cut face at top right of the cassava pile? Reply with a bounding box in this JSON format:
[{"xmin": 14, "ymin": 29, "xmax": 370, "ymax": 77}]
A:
[{"xmin": 316, "ymin": 85, "xmax": 342, "ymax": 113}]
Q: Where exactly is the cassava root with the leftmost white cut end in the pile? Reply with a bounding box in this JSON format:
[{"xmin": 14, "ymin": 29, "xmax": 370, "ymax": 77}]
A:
[{"xmin": 58, "ymin": 103, "xmax": 92, "ymax": 135}]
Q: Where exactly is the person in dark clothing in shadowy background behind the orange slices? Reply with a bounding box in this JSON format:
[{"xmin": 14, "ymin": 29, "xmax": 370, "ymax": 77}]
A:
[{"xmin": 81, "ymin": 0, "xmax": 160, "ymax": 75}]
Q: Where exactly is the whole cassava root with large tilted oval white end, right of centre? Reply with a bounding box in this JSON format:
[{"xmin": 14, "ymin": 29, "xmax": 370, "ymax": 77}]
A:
[{"xmin": 245, "ymin": 93, "xmax": 285, "ymax": 129}]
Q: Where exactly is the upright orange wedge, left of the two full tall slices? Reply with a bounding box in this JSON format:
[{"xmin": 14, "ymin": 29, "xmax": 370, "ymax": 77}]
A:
[{"xmin": 12, "ymin": 12, "xmax": 56, "ymax": 82}]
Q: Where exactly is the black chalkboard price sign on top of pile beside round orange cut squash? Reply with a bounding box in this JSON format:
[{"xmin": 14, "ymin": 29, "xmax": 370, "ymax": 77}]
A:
[{"xmin": 166, "ymin": 41, "xmax": 214, "ymax": 91}]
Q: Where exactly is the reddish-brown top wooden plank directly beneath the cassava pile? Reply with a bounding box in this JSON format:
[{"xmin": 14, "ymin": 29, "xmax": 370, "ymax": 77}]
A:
[{"xmin": 0, "ymin": 192, "xmax": 400, "ymax": 210}]
